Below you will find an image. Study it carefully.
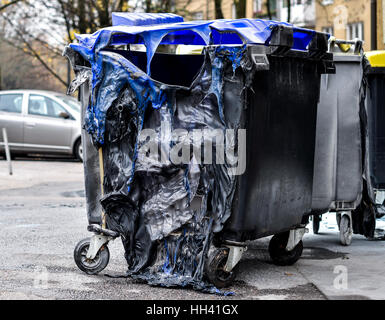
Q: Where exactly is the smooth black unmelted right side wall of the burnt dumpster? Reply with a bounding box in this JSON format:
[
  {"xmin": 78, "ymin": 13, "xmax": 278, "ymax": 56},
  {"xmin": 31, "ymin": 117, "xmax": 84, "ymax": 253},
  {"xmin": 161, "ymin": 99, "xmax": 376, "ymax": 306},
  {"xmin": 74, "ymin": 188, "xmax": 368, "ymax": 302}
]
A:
[{"xmin": 225, "ymin": 57, "xmax": 320, "ymax": 241}]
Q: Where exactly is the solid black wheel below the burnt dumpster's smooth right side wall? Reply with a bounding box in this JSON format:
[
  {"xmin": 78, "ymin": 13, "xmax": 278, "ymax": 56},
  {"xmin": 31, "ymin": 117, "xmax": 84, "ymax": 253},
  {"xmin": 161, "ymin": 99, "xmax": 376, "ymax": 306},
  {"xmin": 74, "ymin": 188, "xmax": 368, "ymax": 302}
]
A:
[{"xmin": 269, "ymin": 232, "xmax": 303, "ymax": 266}]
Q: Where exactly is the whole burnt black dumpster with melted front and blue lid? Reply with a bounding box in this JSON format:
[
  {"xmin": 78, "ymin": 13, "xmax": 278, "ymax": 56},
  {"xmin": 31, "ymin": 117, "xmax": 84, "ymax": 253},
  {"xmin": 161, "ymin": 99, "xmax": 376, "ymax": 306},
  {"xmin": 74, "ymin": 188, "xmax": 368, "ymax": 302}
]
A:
[{"xmin": 65, "ymin": 14, "xmax": 334, "ymax": 292}]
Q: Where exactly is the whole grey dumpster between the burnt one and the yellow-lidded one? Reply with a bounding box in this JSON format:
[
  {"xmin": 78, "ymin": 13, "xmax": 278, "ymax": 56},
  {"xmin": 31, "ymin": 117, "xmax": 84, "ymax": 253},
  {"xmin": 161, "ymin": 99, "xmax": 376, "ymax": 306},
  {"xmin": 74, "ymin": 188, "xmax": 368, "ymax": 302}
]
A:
[{"xmin": 312, "ymin": 38, "xmax": 366, "ymax": 245}]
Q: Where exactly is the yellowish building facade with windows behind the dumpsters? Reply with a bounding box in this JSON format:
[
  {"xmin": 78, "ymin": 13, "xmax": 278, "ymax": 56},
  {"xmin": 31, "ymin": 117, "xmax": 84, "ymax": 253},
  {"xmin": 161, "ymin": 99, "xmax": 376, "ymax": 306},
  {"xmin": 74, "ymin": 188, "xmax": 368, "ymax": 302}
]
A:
[{"xmin": 176, "ymin": 0, "xmax": 385, "ymax": 51}]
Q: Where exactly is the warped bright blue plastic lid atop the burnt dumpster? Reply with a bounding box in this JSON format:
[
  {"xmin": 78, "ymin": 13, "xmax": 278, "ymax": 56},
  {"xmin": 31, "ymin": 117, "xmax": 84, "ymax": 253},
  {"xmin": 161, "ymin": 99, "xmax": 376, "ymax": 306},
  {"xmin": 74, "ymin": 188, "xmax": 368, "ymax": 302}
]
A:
[{"xmin": 71, "ymin": 13, "xmax": 316, "ymax": 74}]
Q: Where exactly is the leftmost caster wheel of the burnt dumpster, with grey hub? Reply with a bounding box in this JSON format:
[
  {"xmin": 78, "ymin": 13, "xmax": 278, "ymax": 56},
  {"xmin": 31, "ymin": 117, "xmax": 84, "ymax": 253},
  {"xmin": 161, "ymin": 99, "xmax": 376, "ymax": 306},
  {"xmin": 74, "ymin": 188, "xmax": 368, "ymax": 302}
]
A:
[{"xmin": 74, "ymin": 238, "xmax": 110, "ymax": 274}]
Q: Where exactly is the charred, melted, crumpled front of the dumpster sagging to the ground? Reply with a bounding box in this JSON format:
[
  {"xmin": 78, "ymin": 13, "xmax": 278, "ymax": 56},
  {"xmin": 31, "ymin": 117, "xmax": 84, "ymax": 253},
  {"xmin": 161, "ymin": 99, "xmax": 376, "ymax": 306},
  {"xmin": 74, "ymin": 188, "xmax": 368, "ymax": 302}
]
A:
[{"xmin": 66, "ymin": 21, "xmax": 264, "ymax": 294}]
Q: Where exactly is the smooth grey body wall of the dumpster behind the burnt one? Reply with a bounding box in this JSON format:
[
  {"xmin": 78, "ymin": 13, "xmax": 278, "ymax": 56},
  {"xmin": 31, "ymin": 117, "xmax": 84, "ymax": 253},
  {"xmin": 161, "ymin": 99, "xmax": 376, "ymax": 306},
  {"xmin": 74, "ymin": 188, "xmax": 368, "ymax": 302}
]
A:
[{"xmin": 312, "ymin": 57, "xmax": 363, "ymax": 212}]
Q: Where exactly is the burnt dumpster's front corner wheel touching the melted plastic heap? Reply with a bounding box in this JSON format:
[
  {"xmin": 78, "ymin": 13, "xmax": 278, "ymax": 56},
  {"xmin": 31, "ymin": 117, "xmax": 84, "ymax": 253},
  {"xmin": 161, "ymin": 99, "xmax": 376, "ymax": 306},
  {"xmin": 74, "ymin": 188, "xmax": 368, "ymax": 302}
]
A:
[{"xmin": 206, "ymin": 248, "xmax": 237, "ymax": 288}]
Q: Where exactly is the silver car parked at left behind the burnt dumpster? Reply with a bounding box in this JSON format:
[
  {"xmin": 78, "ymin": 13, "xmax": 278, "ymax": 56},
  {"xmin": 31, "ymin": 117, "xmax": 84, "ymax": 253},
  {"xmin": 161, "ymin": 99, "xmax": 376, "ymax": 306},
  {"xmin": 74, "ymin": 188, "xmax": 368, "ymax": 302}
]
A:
[{"xmin": 0, "ymin": 90, "xmax": 83, "ymax": 161}]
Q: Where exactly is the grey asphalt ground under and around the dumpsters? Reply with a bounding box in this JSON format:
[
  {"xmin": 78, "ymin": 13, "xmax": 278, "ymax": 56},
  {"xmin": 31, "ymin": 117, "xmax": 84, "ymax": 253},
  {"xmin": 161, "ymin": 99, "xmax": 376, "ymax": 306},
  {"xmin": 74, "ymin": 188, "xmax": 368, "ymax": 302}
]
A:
[{"xmin": 0, "ymin": 159, "xmax": 385, "ymax": 300}]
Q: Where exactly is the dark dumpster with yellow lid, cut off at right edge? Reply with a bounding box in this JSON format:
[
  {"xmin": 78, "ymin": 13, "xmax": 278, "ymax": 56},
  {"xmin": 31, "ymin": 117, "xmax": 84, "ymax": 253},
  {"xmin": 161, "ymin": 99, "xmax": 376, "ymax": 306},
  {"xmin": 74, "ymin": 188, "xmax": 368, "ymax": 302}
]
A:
[{"xmin": 353, "ymin": 51, "xmax": 385, "ymax": 238}]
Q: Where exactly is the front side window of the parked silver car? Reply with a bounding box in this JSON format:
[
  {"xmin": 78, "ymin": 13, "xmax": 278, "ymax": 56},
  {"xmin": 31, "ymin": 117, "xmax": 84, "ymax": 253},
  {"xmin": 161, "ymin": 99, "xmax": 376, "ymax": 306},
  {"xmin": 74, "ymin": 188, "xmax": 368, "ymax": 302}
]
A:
[{"xmin": 28, "ymin": 94, "xmax": 67, "ymax": 118}]
